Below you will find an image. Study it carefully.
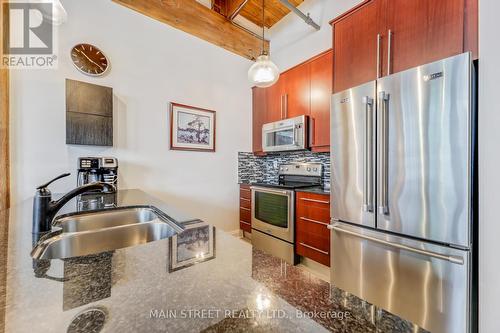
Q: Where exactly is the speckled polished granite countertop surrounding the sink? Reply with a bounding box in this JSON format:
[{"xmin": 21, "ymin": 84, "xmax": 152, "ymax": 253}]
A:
[{"xmin": 0, "ymin": 190, "xmax": 426, "ymax": 333}]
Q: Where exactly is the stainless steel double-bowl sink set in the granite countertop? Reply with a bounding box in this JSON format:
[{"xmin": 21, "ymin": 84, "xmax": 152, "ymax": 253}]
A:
[{"xmin": 31, "ymin": 207, "xmax": 183, "ymax": 259}]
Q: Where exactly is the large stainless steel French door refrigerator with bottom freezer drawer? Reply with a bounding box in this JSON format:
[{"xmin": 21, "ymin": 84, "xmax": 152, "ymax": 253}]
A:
[{"xmin": 329, "ymin": 53, "xmax": 475, "ymax": 333}]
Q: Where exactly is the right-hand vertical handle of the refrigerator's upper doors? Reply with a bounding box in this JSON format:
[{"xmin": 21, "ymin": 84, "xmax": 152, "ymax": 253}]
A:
[{"xmin": 378, "ymin": 91, "xmax": 389, "ymax": 215}]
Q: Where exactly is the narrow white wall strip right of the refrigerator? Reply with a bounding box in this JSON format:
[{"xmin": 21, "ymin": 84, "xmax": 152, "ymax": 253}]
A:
[{"xmin": 479, "ymin": 0, "xmax": 500, "ymax": 333}]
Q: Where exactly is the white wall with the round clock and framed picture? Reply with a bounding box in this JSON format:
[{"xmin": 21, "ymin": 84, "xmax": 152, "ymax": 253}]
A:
[{"xmin": 11, "ymin": 0, "xmax": 251, "ymax": 230}]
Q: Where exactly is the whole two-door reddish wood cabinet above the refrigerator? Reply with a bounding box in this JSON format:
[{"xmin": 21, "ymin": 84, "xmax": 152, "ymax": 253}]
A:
[{"xmin": 331, "ymin": 0, "xmax": 478, "ymax": 92}]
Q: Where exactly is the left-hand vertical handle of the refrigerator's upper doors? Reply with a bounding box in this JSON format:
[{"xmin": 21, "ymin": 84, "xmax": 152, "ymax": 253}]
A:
[{"xmin": 363, "ymin": 96, "xmax": 373, "ymax": 212}]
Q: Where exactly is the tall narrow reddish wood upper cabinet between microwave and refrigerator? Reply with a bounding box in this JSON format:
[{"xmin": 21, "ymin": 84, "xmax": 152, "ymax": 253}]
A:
[{"xmin": 310, "ymin": 50, "xmax": 333, "ymax": 151}]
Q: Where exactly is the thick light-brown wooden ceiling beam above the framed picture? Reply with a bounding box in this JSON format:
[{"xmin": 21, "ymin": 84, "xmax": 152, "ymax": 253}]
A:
[{"xmin": 112, "ymin": 0, "xmax": 269, "ymax": 60}]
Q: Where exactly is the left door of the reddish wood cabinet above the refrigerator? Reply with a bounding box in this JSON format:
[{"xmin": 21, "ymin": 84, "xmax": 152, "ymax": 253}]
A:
[{"xmin": 332, "ymin": 0, "xmax": 382, "ymax": 92}]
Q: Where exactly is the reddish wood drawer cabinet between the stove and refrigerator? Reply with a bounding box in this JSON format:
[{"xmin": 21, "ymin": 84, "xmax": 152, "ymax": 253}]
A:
[{"xmin": 295, "ymin": 192, "xmax": 330, "ymax": 266}]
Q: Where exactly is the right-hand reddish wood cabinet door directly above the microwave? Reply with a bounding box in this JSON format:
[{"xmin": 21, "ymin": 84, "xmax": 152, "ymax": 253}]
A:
[{"xmin": 280, "ymin": 63, "xmax": 311, "ymax": 119}]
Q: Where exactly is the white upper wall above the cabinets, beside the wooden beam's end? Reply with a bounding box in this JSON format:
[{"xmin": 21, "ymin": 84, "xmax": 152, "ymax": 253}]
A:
[{"xmin": 268, "ymin": 0, "xmax": 362, "ymax": 71}]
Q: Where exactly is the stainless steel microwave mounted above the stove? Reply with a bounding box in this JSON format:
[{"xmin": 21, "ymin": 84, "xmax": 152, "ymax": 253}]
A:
[{"xmin": 262, "ymin": 116, "xmax": 308, "ymax": 152}]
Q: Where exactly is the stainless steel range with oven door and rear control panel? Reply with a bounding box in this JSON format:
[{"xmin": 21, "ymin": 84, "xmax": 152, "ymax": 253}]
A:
[{"xmin": 251, "ymin": 163, "xmax": 323, "ymax": 265}]
